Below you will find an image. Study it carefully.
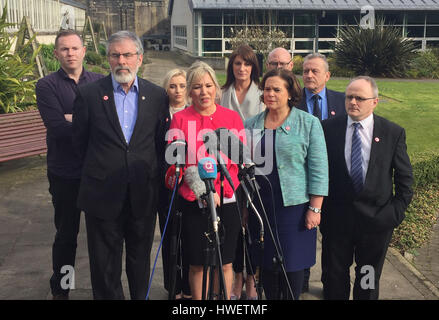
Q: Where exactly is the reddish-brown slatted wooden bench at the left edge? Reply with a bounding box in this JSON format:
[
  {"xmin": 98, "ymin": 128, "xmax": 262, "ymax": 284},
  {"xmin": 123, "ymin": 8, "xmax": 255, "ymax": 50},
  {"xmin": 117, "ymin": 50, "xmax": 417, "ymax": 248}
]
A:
[{"xmin": 0, "ymin": 110, "xmax": 47, "ymax": 162}]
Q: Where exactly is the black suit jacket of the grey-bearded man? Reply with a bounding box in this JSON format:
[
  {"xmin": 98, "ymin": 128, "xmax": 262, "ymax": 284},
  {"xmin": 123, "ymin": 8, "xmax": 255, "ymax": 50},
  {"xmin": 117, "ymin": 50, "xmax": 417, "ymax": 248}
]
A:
[{"xmin": 73, "ymin": 75, "xmax": 168, "ymax": 219}]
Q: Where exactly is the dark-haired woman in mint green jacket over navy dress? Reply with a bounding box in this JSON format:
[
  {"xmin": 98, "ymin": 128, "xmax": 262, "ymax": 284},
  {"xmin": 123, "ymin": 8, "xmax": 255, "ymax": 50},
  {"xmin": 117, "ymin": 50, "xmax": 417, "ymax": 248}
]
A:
[{"xmin": 245, "ymin": 69, "xmax": 328, "ymax": 299}]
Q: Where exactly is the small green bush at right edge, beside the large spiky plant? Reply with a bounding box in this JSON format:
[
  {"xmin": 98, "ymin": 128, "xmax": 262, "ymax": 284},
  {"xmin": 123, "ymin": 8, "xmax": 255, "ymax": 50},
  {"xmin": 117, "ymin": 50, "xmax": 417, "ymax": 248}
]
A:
[{"xmin": 408, "ymin": 49, "xmax": 439, "ymax": 79}]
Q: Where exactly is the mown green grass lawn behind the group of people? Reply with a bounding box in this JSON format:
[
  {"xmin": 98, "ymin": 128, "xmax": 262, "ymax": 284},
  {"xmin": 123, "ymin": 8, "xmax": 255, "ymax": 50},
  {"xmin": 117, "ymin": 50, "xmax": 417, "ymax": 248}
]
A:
[{"xmin": 217, "ymin": 72, "xmax": 439, "ymax": 161}]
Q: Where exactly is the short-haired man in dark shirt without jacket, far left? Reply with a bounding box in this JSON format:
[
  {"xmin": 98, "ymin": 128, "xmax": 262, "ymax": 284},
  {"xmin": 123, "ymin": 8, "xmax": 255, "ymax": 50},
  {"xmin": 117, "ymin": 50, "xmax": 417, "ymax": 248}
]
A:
[{"xmin": 35, "ymin": 30, "xmax": 103, "ymax": 300}]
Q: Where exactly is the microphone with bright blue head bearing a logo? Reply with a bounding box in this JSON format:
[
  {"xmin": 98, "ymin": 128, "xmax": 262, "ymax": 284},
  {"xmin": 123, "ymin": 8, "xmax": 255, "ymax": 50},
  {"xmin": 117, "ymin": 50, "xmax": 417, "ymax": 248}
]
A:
[{"xmin": 198, "ymin": 157, "xmax": 218, "ymax": 234}]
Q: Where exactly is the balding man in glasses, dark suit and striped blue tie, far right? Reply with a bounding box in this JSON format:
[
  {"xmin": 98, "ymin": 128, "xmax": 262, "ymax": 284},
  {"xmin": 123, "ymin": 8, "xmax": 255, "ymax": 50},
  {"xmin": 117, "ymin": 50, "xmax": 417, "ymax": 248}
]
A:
[{"xmin": 320, "ymin": 76, "xmax": 413, "ymax": 300}]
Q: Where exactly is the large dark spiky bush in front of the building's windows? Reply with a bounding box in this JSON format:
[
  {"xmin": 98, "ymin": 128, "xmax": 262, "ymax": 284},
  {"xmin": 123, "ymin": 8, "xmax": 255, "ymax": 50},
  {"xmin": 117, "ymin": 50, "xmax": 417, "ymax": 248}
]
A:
[{"xmin": 334, "ymin": 20, "xmax": 415, "ymax": 77}]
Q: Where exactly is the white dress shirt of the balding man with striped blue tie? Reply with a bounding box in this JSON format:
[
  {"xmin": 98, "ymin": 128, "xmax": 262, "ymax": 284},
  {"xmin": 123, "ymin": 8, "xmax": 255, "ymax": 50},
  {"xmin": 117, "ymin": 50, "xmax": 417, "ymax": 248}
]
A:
[{"xmin": 344, "ymin": 113, "xmax": 373, "ymax": 184}]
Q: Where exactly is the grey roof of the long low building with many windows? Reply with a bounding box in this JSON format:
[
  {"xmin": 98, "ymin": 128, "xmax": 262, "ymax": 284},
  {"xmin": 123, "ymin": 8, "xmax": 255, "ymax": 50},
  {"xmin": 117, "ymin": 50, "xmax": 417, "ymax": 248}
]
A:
[{"xmin": 189, "ymin": 0, "xmax": 439, "ymax": 11}]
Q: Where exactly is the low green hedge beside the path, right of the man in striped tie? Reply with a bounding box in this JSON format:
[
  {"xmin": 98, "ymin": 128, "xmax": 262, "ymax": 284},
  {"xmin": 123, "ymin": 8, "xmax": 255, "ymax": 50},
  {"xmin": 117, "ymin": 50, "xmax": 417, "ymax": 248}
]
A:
[{"xmin": 391, "ymin": 152, "xmax": 439, "ymax": 255}]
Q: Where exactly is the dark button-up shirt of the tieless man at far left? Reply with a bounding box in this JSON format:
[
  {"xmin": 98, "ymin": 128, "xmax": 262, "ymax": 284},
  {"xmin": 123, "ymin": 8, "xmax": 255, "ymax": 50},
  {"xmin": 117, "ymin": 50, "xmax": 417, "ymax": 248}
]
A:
[{"xmin": 35, "ymin": 68, "xmax": 104, "ymax": 179}]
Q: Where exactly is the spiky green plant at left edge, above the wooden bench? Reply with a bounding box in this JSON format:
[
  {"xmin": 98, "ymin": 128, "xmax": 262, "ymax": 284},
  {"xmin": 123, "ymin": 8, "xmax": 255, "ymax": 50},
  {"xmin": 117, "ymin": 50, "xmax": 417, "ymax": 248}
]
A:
[{"xmin": 0, "ymin": 6, "xmax": 38, "ymax": 113}]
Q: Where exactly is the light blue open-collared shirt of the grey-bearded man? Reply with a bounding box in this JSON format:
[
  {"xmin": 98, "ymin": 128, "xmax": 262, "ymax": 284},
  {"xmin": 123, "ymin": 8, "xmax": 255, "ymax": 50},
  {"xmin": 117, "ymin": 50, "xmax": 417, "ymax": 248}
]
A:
[{"xmin": 111, "ymin": 75, "xmax": 139, "ymax": 144}]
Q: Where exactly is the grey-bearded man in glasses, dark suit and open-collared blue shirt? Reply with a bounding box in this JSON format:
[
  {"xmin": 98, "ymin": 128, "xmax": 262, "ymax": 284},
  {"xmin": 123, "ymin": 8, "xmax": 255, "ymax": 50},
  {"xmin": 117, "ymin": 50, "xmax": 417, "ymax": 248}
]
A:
[{"xmin": 73, "ymin": 31, "xmax": 168, "ymax": 300}]
